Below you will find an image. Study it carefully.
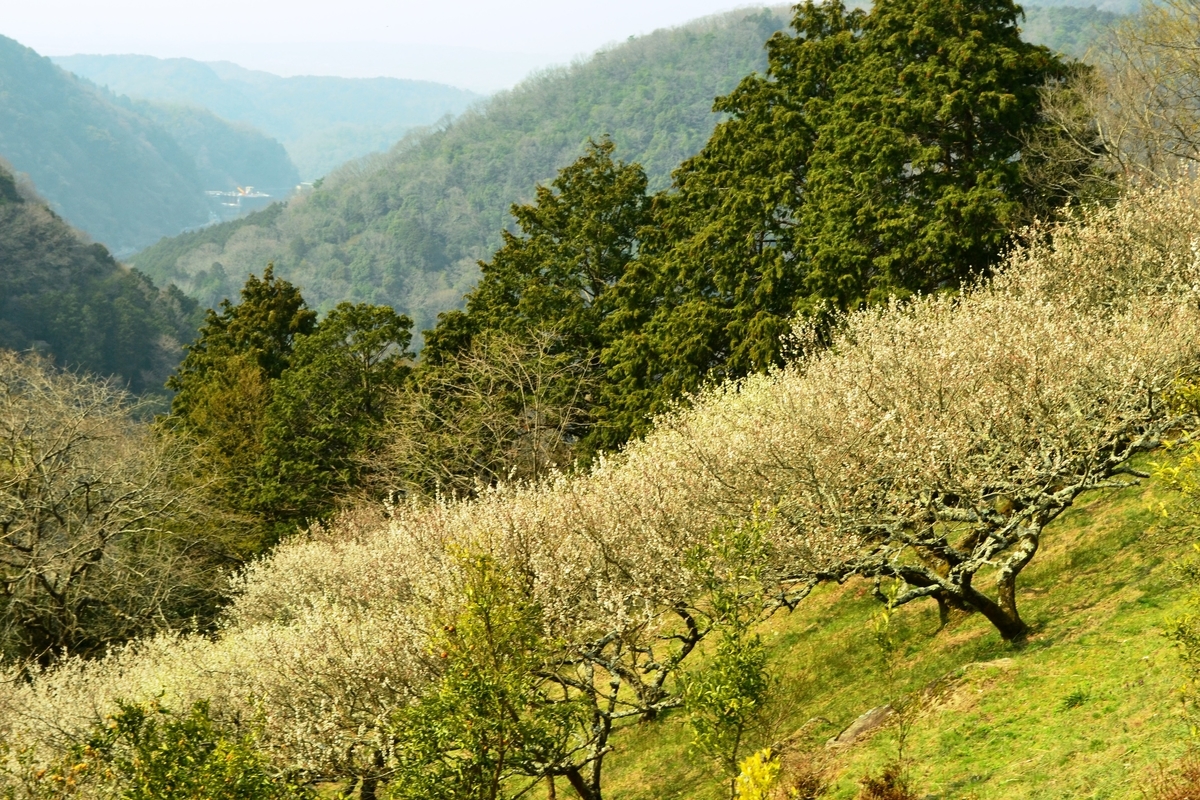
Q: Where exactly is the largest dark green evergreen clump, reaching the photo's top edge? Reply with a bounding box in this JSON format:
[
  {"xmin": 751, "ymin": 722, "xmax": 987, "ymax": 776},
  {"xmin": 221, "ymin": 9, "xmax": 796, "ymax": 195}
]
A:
[{"xmin": 598, "ymin": 0, "xmax": 1068, "ymax": 446}]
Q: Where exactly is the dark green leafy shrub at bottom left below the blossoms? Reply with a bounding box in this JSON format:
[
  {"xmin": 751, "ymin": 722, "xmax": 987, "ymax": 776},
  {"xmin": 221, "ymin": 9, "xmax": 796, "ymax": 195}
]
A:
[{"xmin": 72, "ymin": 700, "xmax": 313, "ymax": 800}]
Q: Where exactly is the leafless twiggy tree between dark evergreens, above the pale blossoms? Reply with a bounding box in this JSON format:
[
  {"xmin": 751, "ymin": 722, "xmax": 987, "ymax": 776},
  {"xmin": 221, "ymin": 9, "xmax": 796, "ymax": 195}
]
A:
[{"xmin": 371, "ymin": 331, "xmax": 594, "ymax": 497}]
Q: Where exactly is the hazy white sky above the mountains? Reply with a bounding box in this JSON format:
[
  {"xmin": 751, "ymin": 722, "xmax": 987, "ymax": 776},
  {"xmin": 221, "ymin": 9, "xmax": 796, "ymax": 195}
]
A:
[{"xmin": 9, "ymin": 0, "xmax": 748, "ymax": 91}]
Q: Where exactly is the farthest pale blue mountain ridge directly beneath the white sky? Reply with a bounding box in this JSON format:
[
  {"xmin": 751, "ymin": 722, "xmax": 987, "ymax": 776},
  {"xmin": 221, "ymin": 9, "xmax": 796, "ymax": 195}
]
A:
[{"xmin": 54, "ymin": 55, "xmax": 481, "ymax": 180}]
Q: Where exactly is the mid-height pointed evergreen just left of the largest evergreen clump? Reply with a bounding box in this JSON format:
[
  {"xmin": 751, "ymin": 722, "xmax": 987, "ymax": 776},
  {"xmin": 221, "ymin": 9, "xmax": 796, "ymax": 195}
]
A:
[{"xmin": 418, "ymin": 138, "xmax": 648, "ymax": 460}]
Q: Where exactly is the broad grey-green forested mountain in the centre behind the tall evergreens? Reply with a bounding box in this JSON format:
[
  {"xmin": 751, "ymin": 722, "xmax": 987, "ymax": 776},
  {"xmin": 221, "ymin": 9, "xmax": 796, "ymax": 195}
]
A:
[{"xmin": 132, "ymin": 11, "xmax": 786, "ymax": 329}]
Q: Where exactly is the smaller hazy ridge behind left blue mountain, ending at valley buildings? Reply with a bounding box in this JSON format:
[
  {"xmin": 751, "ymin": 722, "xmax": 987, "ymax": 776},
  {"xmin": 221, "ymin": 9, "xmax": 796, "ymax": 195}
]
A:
[{"xmin": 119, "ymin": 97, "xmax": 300, "ymax": 197}]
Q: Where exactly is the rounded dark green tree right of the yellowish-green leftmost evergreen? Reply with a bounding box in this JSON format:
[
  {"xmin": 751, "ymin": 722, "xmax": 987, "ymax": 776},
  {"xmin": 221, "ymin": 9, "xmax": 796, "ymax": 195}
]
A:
[{"xmin": 256, "ymin": 302, "xmax": 412, "ymax": 527}]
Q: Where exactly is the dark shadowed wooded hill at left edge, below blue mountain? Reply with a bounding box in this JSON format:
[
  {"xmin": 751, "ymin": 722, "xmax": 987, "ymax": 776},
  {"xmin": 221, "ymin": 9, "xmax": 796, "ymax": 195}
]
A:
[{"xmin": 0, "ymin": 166, "xmax": 199, "ymax": 393}]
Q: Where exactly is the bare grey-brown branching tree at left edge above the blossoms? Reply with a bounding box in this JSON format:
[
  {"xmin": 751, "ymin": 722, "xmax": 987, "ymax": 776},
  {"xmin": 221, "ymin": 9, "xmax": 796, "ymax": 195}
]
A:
[{"xmin": 0, "ymin": 351, "xmax": 220, "ymax": 663}]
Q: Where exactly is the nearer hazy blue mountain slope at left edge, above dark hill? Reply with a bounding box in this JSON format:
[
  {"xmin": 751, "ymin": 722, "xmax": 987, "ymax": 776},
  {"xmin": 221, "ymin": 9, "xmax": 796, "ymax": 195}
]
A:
[{"xmin": 0, "ymin": 37, "xmax": 209, "ymax": 252}]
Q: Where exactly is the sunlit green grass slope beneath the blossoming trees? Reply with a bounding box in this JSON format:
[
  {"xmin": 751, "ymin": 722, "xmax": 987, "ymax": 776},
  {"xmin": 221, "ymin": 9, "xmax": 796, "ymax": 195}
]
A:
[{"xmin": 590, "ymin": 455, "xmax": 1190, "ymax": 800}]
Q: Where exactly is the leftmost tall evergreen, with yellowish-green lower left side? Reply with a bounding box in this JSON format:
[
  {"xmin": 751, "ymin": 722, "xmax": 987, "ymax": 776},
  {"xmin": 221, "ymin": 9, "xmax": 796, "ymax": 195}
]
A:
[{"xmin": 167, "ymin": 265, "xmax": 317, "ymax": 525}]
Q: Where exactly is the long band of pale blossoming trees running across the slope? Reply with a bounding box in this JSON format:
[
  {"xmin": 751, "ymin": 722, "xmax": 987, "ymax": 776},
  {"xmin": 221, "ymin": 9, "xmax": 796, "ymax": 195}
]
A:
[{"xmin": 7, "ymin": 184, "xmax": 1200, "ymax": 775}]
